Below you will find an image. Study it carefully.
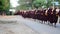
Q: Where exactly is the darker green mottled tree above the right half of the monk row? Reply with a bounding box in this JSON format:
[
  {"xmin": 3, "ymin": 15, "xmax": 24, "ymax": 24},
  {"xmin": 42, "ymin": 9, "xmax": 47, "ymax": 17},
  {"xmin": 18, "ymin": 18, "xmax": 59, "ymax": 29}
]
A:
[{"xmin": 33, "ymin": 0, "xmax": 53, "ymax": 8}]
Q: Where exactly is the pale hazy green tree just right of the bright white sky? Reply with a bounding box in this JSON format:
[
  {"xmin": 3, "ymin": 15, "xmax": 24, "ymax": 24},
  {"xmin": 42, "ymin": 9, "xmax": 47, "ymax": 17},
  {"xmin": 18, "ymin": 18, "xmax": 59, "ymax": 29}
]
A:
[{"xmin": 16, "ymin": 0, "xmax": 32, "ymax": 10}]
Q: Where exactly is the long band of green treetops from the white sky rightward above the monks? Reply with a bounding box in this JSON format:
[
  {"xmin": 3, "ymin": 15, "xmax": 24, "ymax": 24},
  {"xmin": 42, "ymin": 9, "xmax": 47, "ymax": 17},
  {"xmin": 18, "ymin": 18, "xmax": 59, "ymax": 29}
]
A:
[{"xmin": 16, "ymin": 0, "xmax": 55, "ymax": 10}]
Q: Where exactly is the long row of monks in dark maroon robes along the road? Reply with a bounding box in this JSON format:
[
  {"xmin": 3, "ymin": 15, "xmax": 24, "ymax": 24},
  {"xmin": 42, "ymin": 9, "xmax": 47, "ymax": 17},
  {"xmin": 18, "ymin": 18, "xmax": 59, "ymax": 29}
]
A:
[{"xmin": 15, "ymin": 8, "xmax": 60, "ymax": 27}]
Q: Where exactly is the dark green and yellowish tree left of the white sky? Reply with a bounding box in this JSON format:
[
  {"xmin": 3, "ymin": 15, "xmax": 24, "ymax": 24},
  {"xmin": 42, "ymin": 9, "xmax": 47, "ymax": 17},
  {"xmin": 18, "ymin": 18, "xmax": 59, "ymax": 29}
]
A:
[{"xmin": 0, "ymin": 0, "xmax": 10, "ymax": 13}]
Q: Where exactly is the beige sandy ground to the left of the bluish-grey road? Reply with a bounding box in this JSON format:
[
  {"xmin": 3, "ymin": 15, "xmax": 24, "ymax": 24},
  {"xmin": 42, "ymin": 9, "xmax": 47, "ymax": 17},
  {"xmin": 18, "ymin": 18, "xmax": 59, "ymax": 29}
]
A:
[{"xmin": 0, "ymin": 16, "xmax": 40, "ymax": 34}]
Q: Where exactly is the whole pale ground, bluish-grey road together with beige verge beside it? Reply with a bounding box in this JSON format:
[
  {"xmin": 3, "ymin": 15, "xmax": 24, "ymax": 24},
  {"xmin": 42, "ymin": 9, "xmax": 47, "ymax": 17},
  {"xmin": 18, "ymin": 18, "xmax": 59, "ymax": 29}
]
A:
[{"xmin": 0, "ymin": 16, "xmax": 60, "ymax": 34}]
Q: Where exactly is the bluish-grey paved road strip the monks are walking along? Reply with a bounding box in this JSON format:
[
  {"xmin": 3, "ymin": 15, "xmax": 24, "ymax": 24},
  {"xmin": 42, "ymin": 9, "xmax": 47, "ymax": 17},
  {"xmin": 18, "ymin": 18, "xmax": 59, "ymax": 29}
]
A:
[{"xmin": 17, "ymin": 15, "xmax": 60, "ymax": 34}]
